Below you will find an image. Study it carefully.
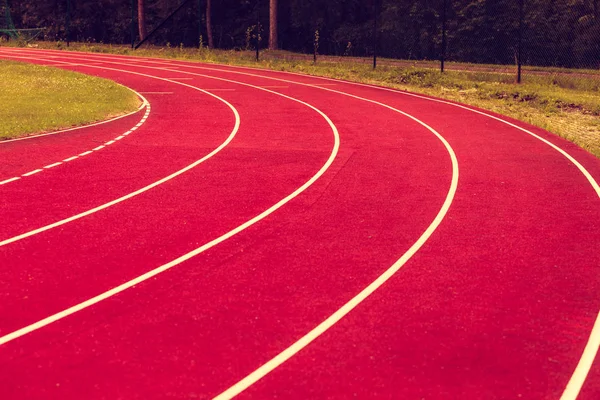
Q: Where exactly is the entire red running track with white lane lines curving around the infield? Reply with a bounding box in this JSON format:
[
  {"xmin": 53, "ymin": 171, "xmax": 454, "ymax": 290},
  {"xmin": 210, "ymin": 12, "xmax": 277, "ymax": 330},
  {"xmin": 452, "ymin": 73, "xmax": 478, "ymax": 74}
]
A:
[{"xmin": 0, "ymin": 48, "xmax": 600, "ymax": 399}]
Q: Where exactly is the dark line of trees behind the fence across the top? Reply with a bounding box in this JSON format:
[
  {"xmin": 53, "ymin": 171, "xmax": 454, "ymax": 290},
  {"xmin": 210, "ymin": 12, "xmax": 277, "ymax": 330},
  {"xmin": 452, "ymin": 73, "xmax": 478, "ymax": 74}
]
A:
[{"xmin": 9, "ymin": 0, "xmax": 600, "ymax": 68}]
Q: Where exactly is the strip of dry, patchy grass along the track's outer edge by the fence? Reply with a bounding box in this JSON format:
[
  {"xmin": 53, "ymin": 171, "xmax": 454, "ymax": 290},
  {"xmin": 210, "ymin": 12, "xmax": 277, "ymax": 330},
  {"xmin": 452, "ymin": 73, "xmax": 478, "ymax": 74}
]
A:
[{"xmin": 4, "ymin": 42, "xmax": 600, "ymax": 157}]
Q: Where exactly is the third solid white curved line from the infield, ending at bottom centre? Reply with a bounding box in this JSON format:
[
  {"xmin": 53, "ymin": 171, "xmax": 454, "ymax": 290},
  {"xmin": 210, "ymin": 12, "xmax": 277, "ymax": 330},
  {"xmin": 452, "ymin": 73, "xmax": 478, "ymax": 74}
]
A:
[{"xmin": 16, "ymin": 50, "xmax": 459, "ymax": 400}]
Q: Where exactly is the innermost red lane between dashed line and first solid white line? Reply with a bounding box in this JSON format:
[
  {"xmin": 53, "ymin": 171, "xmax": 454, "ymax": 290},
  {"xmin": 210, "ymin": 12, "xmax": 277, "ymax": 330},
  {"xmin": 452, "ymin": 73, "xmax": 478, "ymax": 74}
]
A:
[{"xmin": 0, "ymin": 56, "xmax": 237, "ymax": 241}]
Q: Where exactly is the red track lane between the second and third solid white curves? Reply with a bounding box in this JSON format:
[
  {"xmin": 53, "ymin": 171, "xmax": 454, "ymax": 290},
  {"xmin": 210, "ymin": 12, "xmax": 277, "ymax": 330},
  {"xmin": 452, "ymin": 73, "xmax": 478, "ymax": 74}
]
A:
[{"xmin": 3, "ymin": 108, "xmax": 447, "ymax": 397}]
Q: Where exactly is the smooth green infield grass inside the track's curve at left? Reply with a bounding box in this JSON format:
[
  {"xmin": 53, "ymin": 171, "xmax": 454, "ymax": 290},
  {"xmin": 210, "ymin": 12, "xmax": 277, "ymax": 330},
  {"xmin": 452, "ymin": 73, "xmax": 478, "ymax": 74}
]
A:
[{"xmin": 0, "ymin": 61, "xmax": 140, "ymax": 140}]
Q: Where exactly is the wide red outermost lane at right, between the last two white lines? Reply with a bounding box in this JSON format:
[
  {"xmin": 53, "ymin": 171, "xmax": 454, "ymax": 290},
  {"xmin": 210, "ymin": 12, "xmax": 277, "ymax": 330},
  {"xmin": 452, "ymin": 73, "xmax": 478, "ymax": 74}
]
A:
[{"xmin": 1, "ymin": 47, "xmax": 598, "ymax": 398}]
